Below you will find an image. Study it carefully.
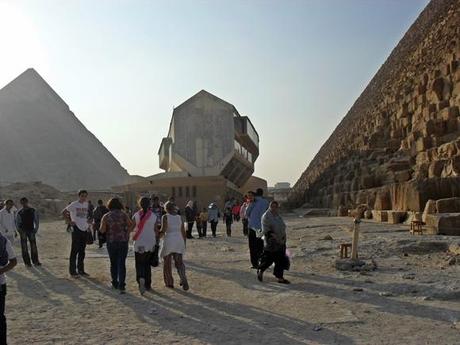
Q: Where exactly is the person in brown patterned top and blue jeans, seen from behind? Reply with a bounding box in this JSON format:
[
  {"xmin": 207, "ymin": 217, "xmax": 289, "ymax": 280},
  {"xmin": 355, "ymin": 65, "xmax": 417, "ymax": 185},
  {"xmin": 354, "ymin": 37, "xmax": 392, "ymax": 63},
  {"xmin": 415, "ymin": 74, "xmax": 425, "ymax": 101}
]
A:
[{"xmin": 99, "ymin": 198, "xmax": 134, "ymax": 294}]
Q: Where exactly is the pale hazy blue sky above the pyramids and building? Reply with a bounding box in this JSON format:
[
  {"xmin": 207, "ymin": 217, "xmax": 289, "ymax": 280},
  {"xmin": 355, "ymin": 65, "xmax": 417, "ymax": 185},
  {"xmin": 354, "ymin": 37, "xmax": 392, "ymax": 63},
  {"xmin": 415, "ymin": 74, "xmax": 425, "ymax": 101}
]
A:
[{"xmin": 0, "ymin": 0, "xmax": 428, "ymax": 185}]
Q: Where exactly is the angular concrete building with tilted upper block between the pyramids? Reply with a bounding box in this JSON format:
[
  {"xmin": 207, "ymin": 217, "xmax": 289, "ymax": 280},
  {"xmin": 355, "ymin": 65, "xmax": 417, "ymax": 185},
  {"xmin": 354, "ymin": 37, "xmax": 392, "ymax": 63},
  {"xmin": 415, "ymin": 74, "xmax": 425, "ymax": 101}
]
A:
[{"xmin": 117, "ymin": 90, "xmax": 267, "ymax": 207}]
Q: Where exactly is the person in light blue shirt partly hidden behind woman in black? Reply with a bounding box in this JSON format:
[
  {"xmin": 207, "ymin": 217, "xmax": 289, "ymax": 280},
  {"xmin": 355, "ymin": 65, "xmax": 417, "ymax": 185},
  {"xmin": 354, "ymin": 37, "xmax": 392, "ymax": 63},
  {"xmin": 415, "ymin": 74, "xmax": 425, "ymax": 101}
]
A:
[{"xmin": 246, "ymin": 188, "xmax": 268, "ymax": 269}]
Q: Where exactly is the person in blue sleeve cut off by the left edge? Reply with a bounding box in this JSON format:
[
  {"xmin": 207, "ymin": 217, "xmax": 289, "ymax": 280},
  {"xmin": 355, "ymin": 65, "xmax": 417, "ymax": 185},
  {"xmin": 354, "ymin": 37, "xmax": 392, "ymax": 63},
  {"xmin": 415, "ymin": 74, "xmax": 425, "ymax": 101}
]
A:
[{"xmin": 0, "ymin": 234, "xmax": 18, "ymax": 345}]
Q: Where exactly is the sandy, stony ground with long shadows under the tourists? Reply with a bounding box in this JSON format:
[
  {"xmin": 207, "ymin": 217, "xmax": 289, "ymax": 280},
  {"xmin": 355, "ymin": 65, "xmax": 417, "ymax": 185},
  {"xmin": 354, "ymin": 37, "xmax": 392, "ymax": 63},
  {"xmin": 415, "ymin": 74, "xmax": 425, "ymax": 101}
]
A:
[{"xmin": 3, "ymin": 215, "xmax": 460, "ymax": 345}]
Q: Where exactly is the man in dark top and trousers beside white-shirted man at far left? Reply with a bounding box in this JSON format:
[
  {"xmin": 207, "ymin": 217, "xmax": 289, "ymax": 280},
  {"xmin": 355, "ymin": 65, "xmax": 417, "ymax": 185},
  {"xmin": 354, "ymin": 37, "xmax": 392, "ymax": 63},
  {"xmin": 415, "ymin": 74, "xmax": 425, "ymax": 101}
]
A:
[{"xmin": 16, "ymin": 198, "xmax": 41, "ymax": 267}]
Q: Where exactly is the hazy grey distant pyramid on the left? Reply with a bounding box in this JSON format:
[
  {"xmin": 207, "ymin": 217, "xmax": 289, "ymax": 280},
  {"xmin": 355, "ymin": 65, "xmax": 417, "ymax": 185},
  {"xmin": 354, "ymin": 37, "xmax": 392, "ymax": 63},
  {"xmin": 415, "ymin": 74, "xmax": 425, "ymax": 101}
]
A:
[{"xmin": 0, "ymin": 69, "xmax": 129, "ymax": 191}]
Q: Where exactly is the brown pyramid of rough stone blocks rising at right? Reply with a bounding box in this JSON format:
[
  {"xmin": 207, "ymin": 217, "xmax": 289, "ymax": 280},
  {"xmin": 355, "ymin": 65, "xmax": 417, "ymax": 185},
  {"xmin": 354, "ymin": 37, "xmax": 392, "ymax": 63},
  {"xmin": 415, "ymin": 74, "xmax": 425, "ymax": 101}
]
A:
[{"xmin": 289, "ymin": 0, "xmax": 460, "ymax": 211}]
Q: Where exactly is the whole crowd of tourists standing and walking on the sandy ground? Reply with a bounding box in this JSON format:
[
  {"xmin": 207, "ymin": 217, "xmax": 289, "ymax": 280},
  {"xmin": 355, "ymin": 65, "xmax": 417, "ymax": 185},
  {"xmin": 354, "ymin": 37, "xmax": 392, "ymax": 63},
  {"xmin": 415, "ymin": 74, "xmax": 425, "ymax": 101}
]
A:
[{"xmin": 0, "ymin": 189, "xmax": 290, "ymax": 344}]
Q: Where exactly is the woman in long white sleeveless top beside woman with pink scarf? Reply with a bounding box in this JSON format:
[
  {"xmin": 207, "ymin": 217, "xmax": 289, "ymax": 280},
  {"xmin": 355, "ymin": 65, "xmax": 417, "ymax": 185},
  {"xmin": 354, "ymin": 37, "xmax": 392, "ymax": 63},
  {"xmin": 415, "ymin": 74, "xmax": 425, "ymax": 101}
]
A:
[{"xmin": 160, "ymin": 201, "xmax": 189, "ymax": 291}]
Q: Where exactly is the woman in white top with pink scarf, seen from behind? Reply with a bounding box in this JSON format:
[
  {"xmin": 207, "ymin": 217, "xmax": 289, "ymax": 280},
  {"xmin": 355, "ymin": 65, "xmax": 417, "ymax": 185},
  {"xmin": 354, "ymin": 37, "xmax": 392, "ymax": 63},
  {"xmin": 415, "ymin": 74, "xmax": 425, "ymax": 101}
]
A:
[{"xmin": 133, "ymin": 197, "xmax": 158, "ymax": 295}]
